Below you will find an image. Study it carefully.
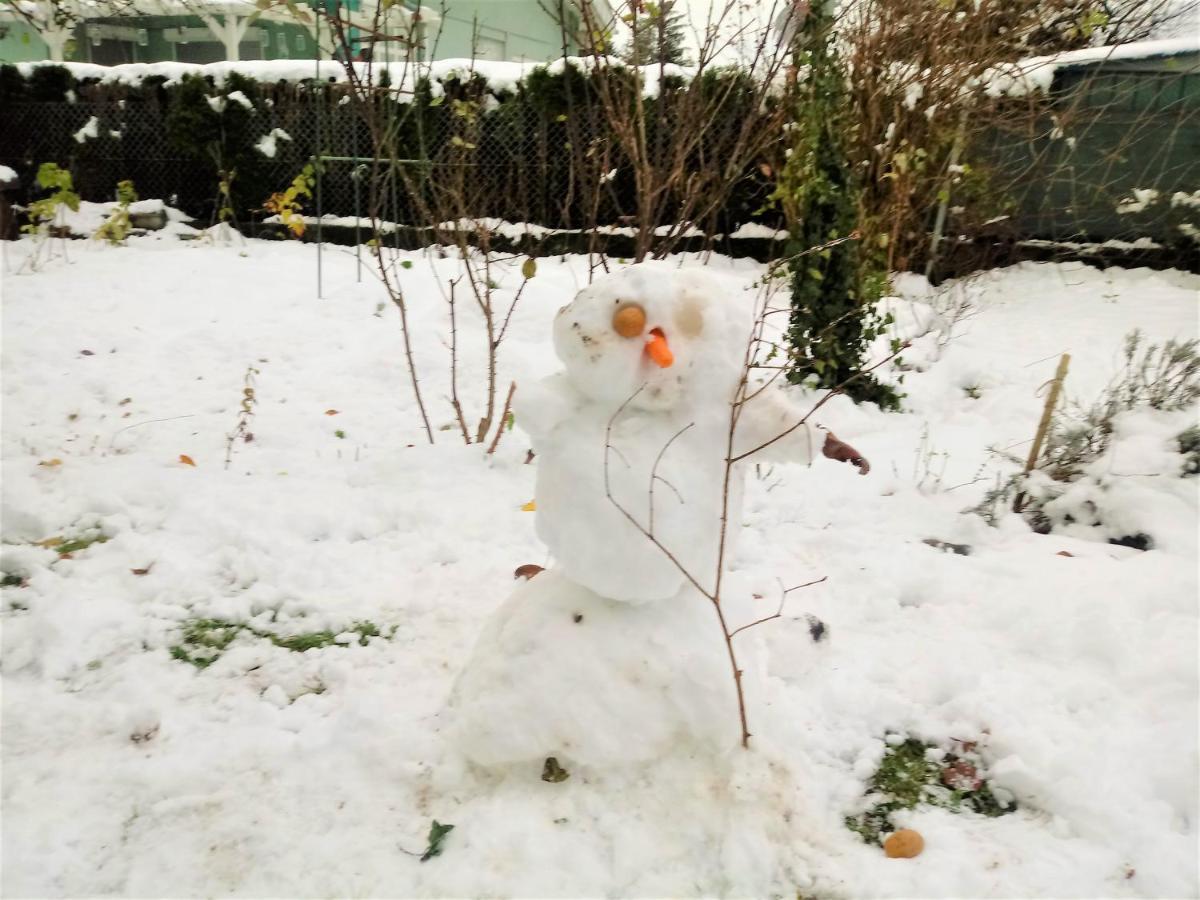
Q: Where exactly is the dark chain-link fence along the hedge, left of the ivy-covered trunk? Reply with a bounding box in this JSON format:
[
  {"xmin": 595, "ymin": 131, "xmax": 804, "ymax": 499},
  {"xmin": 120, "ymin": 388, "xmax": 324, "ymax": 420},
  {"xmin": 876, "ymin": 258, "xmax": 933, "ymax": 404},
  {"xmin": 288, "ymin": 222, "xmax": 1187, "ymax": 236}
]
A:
[{"xmin": 0, "ymin": 85, "xmax": 778, "ymax": 240}]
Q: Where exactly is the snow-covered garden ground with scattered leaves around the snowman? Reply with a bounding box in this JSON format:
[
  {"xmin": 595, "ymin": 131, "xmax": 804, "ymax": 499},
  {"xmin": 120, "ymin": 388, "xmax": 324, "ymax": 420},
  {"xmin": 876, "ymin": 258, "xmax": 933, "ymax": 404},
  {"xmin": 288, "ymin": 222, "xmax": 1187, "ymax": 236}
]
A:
[{"xmin": 2, "ymin": 236, "xmax": 1200, "ymax": 898}]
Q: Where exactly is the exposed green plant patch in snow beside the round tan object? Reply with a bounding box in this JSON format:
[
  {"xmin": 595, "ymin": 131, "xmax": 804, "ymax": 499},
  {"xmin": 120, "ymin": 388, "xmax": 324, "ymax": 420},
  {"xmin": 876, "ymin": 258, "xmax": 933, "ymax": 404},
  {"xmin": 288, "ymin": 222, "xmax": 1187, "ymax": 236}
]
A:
[{"xmin": 845, "ymin": 738, "xmax": 1016, "ymax": 845}]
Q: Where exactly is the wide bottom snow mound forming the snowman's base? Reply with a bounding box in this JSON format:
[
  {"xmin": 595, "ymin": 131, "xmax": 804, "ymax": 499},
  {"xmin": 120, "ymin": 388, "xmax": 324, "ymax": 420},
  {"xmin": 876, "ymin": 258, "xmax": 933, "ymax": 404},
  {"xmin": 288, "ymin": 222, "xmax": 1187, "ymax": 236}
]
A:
[{"xmin": 454, "ymin": 570, "xmax": 739, "ymax": 766}]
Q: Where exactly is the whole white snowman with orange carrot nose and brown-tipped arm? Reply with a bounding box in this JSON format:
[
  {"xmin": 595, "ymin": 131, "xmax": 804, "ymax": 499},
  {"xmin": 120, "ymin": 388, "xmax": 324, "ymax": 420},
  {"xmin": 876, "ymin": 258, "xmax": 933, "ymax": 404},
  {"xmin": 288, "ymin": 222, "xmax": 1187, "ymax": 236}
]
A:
[{"xmin": 452, "ymin": 263, "xmax": 869, "ymax": 766}]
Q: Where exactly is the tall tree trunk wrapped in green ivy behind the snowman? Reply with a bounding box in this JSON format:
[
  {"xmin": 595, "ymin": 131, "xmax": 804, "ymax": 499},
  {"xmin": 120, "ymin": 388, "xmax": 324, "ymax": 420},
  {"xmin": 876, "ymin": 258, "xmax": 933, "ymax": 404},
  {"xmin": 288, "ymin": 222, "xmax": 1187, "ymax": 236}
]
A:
[{"xmin": 774, "ymin": 4, "xmax": 900, "ymax": 409}]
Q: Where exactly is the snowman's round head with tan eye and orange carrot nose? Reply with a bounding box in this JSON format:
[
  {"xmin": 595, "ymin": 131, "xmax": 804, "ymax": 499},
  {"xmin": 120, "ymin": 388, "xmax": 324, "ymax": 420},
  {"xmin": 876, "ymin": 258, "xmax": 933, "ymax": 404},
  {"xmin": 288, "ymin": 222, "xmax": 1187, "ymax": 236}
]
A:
[{"xmin": 554, "ymin": 263, "xmax": 754, "ymax": 410}]
